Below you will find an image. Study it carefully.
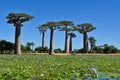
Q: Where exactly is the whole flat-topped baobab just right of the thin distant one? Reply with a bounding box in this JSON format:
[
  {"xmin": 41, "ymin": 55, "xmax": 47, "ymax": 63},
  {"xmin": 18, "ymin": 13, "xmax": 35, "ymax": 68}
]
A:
[{"xmin": 45, "ymin": 22, "xmax": 60, "ymax": 55}]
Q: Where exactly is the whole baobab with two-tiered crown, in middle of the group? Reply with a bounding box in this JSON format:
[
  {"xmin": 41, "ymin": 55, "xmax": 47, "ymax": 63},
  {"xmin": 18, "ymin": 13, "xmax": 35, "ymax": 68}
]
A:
[{"xmin": 59, "ymin": 20, "xmax": 74, "ymax": 53}]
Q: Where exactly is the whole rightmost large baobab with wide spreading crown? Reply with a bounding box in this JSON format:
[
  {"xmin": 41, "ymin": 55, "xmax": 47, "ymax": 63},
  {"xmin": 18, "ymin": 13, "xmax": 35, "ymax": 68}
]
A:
[{"xmin": 74, "ymin": 23, "xmax": 96, "ymax": 53}]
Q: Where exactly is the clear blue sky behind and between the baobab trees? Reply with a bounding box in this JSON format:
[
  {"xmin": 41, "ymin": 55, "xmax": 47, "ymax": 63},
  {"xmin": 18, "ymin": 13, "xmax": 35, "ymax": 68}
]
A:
[{"xmin": 0, "ymin": 0, "xmax": 120, "ymax": 49}]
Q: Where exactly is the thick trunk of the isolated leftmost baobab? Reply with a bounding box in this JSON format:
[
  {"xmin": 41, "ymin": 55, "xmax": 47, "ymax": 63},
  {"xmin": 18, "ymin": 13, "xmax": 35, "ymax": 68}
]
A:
[{"xmin": 14, "ymin": 26, "xmax": 21, "ymax": 54}]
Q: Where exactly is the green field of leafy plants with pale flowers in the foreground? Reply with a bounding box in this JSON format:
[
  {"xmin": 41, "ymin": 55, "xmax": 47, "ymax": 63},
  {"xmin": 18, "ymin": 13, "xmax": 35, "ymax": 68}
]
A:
[{"xmin": 0, "ymin": 55, "xmax": 120, "ymax": 80}]
